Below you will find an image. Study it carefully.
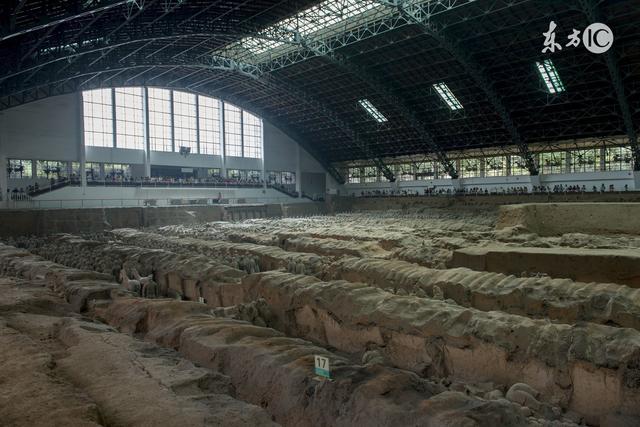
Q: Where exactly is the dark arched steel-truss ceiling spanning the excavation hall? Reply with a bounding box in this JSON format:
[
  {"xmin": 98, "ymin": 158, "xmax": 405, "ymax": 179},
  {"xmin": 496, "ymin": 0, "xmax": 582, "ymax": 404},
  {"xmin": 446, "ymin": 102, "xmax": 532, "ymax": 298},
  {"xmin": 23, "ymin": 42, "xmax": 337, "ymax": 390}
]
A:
[{"xmin": 0, "ymin": 0, "xmax": 640, "ymax": 182}]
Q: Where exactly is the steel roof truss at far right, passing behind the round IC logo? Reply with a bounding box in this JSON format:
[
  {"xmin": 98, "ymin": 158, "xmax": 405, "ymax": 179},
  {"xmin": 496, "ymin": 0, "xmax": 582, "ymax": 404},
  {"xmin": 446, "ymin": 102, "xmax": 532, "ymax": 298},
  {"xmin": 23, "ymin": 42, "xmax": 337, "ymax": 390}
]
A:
[{"xmin": 579, "ymin": 0, "xmax": 640, "ymax": 171}]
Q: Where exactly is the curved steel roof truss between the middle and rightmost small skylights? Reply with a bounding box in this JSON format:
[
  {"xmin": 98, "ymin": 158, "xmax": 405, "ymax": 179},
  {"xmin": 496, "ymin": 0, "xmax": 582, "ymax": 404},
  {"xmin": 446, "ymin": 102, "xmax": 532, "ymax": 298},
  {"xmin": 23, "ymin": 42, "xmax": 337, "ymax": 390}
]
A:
[{"xmin": 378, "ymin": 0, "xmax": 539, "ymax": 175}]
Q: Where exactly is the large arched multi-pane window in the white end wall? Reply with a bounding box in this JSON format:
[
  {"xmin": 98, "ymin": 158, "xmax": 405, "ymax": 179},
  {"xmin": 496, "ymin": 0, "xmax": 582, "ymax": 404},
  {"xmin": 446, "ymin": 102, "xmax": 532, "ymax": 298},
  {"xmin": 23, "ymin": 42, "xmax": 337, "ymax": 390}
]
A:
[{"xmin": 82, "ymin": 87, "xmax": 263, "ymax": 159}]
